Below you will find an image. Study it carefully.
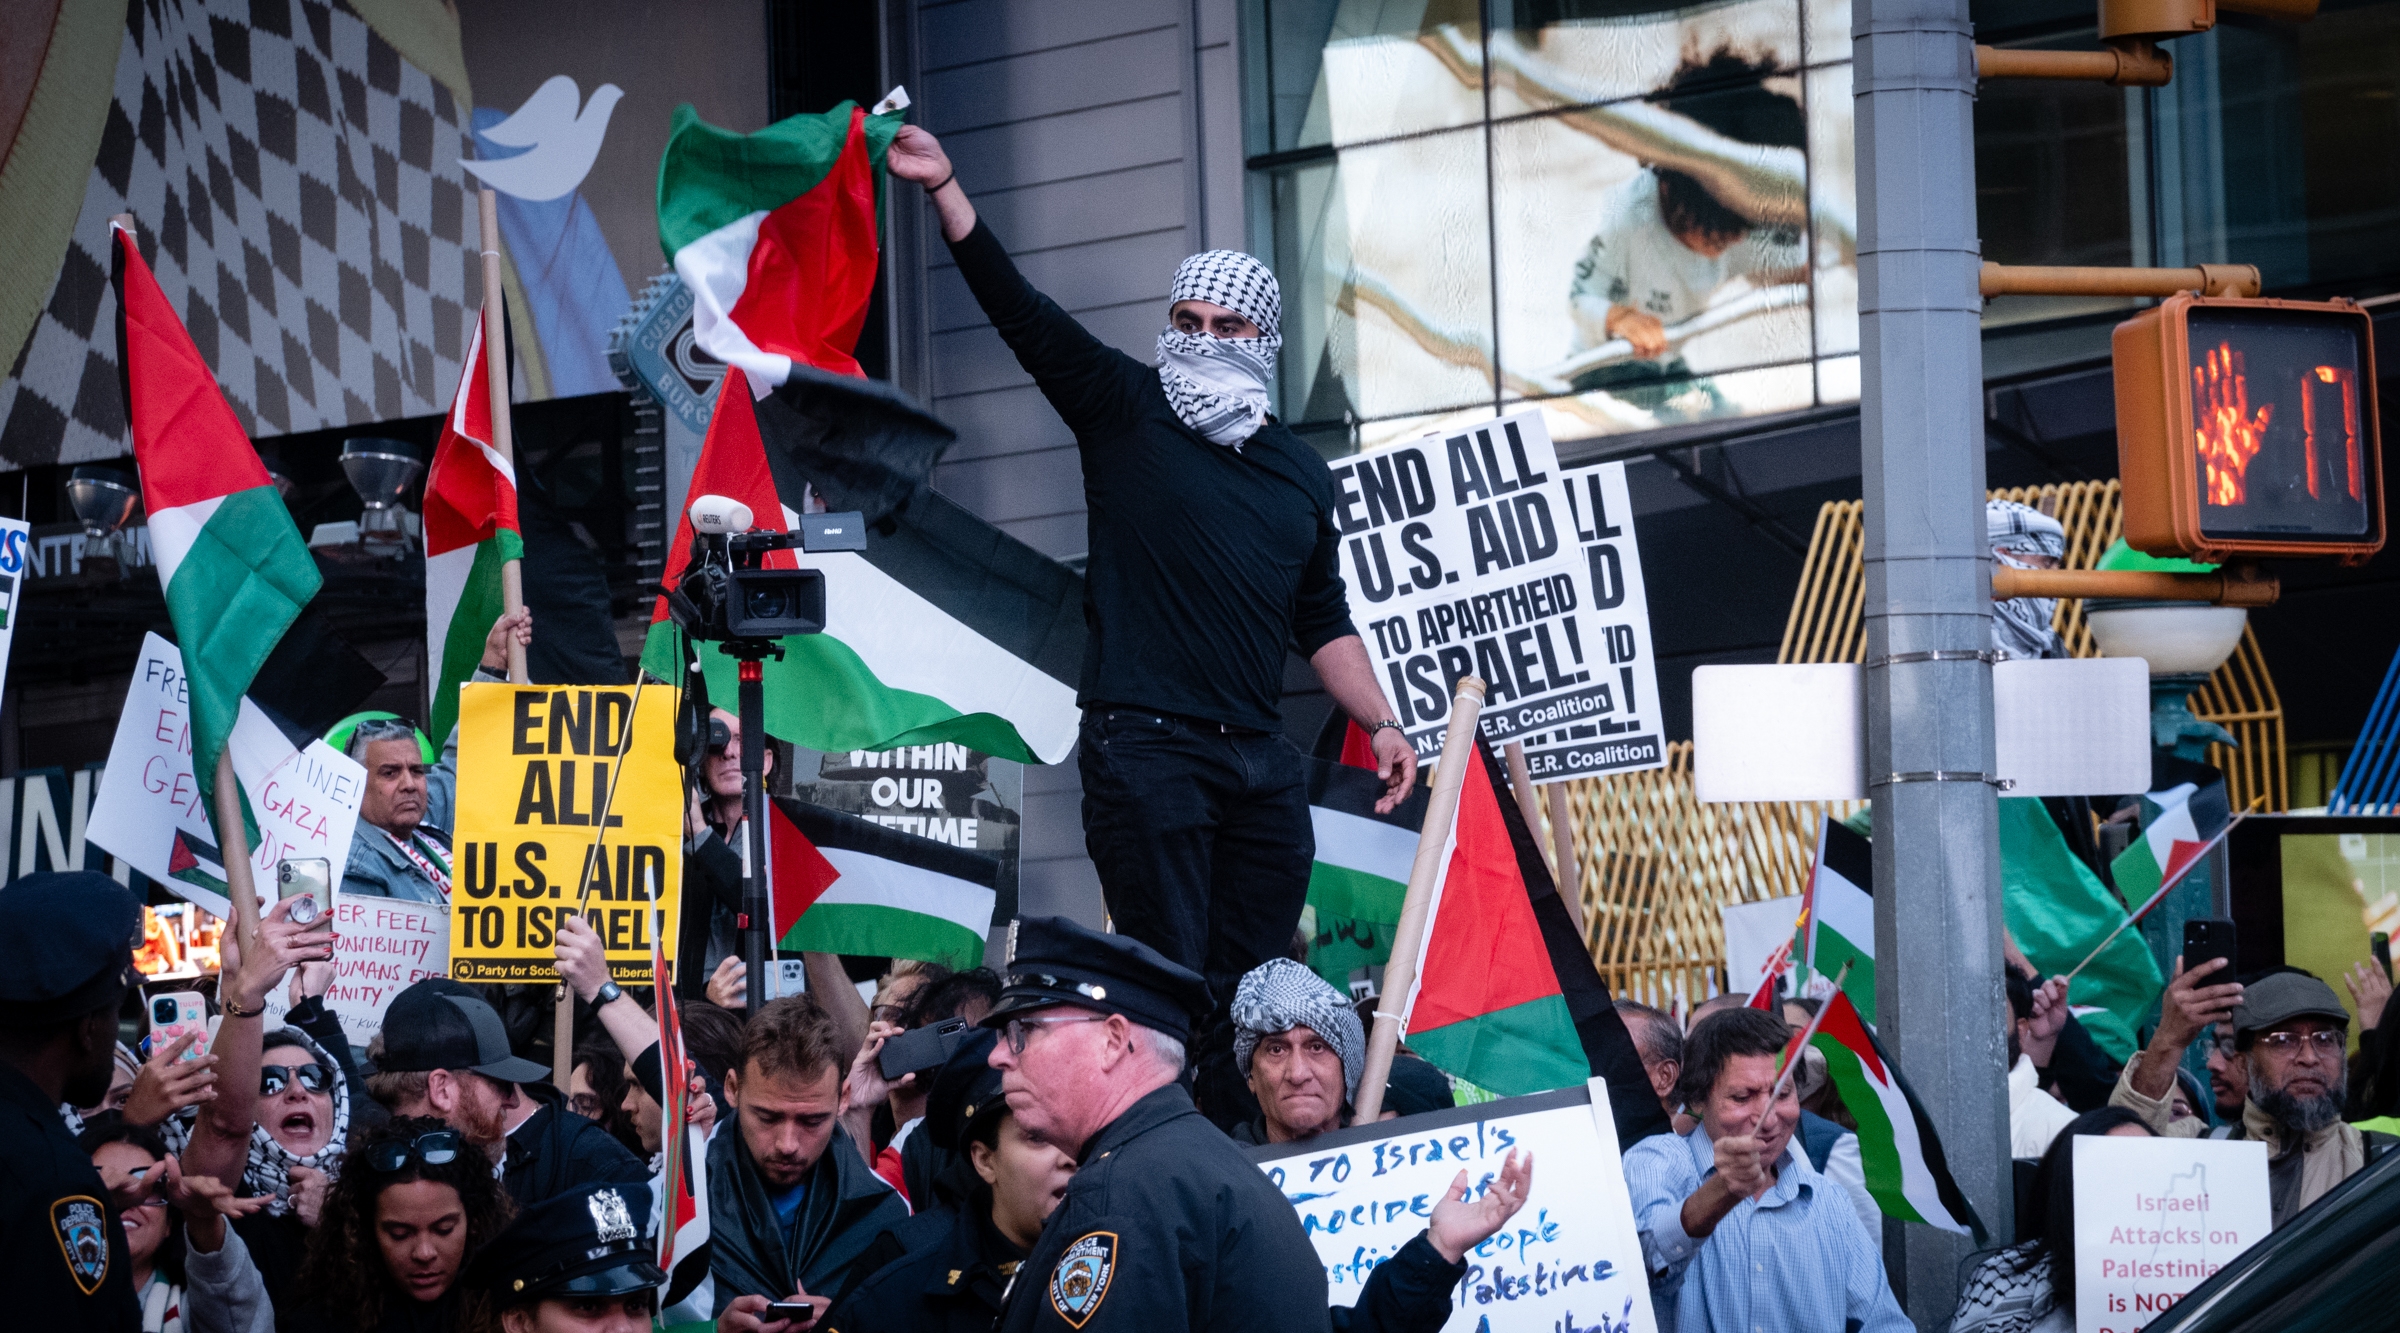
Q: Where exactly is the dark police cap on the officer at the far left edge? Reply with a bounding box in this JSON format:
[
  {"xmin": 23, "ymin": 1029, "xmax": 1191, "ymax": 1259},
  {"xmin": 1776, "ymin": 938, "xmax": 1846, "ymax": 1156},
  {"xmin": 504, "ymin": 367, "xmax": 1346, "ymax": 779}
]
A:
[{"xmin": 0, "ymin": 869, "xmax": 142, "ymax": 1023}]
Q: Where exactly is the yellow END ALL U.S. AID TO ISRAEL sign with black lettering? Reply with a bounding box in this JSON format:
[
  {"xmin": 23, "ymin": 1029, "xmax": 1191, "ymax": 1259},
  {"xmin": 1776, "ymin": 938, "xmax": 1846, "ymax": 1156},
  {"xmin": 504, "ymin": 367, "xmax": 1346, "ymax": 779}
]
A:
[{"xmin": 451, "ymin": 685, "xmax": 684, "ymax": 982}]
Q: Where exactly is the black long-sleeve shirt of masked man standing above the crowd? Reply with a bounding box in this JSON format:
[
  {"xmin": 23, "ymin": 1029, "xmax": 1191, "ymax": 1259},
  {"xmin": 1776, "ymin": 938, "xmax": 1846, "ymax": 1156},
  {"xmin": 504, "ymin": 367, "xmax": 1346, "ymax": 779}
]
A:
[{"xmin": 950, "ymin": 223, "xmax": 1356, "ymax": 730}]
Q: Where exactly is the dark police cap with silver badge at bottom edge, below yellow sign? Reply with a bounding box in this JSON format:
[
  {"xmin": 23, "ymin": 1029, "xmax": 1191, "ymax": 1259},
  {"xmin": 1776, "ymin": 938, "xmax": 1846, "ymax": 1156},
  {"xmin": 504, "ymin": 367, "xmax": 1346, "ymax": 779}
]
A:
[{"xmin": 466, "ymin": 1182, "xmax": 667, "ymax": 1307}]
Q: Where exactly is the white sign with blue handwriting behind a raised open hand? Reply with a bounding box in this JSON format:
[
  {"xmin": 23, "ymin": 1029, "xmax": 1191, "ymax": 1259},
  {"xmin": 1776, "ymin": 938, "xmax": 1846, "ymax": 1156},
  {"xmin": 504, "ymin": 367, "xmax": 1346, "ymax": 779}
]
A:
[{"xmin": 1250, "ymin": 1078, "xmax": 1656, "ymax": 1333}]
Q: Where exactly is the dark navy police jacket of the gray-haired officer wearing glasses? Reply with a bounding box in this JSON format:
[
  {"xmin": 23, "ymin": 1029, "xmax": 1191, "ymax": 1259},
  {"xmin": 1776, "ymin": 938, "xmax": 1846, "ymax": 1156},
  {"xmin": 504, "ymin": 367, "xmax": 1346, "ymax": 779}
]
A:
[{"xmin": 1001, "ymin": 1083, "xmax": 1330, "ymax": 1333}]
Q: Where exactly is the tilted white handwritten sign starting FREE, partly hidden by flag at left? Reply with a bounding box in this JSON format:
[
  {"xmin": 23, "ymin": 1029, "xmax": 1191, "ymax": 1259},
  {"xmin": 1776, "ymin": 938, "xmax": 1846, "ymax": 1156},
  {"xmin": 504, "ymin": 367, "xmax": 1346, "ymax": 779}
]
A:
[{"xmin": 84, "ymin": 634, "xmax": 367, "ymax": 917}]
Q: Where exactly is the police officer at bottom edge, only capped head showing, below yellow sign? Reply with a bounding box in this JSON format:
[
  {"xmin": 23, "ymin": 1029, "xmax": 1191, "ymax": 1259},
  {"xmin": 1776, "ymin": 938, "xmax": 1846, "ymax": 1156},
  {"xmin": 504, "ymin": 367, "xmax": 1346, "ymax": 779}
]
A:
[{"xmin": 463, "ymin": 1184, "xmax": 667, "ymax": 1333}]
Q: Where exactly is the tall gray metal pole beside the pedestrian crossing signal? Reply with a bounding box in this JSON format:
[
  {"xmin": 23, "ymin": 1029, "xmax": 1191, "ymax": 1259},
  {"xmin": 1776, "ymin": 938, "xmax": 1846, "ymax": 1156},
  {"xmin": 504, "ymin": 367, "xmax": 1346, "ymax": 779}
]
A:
[{"xmin": 1850, "ymin": 0, "xmax": 2014, "ymax": 1328}]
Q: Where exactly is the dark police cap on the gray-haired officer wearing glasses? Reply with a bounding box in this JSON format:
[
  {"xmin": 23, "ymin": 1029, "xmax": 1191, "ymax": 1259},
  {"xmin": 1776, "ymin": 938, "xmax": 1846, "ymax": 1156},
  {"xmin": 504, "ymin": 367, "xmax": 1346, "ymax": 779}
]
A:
[{"xmin": 984, "ymin": 917, "xmax": 1210, "ymax": 1042}]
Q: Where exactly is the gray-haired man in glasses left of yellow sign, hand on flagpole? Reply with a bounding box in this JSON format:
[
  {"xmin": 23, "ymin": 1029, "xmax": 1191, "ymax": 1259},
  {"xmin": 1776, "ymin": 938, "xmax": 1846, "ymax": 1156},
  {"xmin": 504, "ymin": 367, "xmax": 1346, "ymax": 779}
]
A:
[{"xmin": 341, "ymin": 610, "xmax": 533, "ymax": 903}]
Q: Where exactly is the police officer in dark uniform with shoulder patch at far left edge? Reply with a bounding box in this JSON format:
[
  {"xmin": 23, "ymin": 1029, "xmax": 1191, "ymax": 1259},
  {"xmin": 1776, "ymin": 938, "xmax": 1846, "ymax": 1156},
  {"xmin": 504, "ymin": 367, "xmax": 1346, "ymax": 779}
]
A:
[{"xmin": 0, "ymin": 869, "xmax": 161, "ymax": 1331}]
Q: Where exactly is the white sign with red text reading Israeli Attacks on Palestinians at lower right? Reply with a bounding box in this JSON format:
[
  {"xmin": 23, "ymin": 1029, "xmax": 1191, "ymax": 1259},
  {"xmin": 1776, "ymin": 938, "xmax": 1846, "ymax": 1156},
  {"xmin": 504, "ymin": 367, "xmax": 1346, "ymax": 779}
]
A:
[{"xmin": 2074, "ymin": 1136, "xmax": 2273, "ymax": 1333}]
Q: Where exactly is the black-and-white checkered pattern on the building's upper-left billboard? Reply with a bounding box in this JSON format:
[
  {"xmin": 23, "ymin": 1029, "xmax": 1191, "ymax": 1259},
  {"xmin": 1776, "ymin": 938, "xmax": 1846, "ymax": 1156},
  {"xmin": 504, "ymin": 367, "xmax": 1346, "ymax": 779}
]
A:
[{"xmin": 0, "ymin": 0, "xmax": 480, "ymax": 468}]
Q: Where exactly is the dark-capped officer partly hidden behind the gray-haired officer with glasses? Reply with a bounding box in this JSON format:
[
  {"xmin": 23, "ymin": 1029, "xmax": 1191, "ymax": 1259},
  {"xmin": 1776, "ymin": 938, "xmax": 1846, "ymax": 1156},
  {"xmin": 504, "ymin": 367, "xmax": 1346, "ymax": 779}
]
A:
[{"xmin": 821, "ymin": 1030, "xmax": 1075, "ymax": 1333}]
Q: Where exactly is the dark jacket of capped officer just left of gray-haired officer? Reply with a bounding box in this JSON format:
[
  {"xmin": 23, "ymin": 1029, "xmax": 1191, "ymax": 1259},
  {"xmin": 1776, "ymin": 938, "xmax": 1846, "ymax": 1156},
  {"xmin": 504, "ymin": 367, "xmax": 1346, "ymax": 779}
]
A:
[{"xmin": 823, "ymin": 1186, "xmax": 1025, "ymax": 1333}]
